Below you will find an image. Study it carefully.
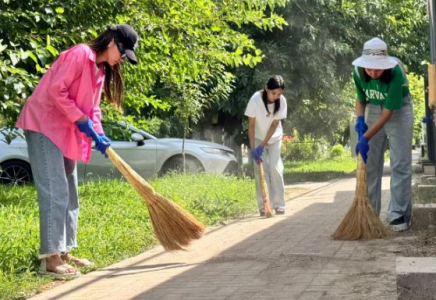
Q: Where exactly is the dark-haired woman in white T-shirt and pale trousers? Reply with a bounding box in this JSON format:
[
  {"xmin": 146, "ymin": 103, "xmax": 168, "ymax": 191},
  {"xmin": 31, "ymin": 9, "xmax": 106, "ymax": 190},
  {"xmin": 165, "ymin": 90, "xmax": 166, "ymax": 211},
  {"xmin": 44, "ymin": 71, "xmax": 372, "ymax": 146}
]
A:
[{"xmin": 245, "ymin": 75, "xmax": 287, "ymax": 216}]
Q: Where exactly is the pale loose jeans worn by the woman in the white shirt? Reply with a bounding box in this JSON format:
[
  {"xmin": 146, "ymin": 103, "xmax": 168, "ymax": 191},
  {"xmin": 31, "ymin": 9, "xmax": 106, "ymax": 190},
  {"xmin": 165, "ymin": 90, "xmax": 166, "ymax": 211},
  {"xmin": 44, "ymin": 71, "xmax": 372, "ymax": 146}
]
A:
[{"xmin": 253, "ymin": 139, "xmax": 286, "ymax": 210}]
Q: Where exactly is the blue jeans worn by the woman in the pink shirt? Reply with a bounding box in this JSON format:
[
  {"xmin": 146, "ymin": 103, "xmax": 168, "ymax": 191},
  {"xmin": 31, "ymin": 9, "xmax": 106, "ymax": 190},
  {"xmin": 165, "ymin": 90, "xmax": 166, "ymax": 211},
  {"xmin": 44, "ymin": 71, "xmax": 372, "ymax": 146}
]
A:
[{"xmin": 25, "ymin": 131, "xmax": 79, "ymax": 259}]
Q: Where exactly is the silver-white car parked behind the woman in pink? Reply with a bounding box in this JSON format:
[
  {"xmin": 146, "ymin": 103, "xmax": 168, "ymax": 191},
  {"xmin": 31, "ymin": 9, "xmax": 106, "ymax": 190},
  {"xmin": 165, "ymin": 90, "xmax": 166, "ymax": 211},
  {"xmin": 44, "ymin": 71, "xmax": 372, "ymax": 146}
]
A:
[{"xmin": 0, "ymin": 124, "xmax": 238, "ymax": 185}]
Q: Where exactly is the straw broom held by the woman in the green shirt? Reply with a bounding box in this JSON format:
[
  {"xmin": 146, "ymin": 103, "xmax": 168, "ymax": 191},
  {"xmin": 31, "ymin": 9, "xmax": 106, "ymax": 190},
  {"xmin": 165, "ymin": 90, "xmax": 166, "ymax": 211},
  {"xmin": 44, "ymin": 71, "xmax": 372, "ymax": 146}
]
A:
[{"xmin": 333, "ymin": 154, "xmax": 387, "ymax": 240}]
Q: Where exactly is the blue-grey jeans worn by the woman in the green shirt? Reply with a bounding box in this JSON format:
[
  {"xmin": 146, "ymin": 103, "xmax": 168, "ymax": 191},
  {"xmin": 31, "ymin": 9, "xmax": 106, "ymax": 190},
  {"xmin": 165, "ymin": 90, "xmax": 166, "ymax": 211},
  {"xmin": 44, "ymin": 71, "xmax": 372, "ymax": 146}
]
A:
[{"xmin": 365, "ymin": 96, "xmax": 413, "ymax": 222}]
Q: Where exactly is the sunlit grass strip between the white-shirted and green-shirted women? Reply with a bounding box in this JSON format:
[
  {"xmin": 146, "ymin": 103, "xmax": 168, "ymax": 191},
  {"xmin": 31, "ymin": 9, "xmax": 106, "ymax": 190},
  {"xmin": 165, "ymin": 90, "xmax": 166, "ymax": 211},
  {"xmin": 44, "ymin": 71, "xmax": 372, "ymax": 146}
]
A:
[{"xmin": 283, "ymin": 156, "xmax": 357, "ymax": 184}]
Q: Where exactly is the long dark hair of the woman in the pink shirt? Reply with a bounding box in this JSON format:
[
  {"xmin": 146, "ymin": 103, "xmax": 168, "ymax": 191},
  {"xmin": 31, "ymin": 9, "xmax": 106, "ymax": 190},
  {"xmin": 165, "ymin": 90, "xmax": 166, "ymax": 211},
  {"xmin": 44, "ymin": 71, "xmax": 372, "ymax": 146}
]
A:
[{"xmin": 88, "ymin": 29, "xmax": 124, "ymax": 109}]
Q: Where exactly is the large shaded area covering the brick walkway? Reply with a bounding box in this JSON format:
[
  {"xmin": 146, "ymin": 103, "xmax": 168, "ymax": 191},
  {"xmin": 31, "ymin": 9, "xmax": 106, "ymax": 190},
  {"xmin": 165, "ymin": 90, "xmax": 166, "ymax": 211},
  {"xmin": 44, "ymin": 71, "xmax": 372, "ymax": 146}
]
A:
[{"xmin": 123, "ymin": 183, "xmax": 396, "ymax": 300}]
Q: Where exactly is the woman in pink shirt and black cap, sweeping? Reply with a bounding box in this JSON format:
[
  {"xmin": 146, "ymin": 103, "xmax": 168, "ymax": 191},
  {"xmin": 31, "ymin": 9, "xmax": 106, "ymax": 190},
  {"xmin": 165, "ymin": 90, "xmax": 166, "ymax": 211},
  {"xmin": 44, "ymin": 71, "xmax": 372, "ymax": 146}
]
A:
[{"xmin": 16, "ymin": 24, "xmax": 139, "ymax": 278}]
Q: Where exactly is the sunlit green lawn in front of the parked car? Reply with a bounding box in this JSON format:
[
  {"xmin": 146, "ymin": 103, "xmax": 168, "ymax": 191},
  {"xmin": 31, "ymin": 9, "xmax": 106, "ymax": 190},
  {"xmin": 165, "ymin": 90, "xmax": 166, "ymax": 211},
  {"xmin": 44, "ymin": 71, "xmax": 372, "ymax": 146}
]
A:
[{"xmin": 0, "ymin": 174, "xmax": 257, "ymax": 300}]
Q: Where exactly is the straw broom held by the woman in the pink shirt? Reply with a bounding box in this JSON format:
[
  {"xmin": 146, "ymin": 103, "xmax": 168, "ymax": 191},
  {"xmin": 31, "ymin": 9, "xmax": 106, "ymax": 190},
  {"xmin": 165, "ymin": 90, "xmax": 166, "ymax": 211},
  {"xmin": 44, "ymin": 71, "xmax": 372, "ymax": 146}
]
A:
[{"xmin": 106, "ymin": 147, "xmax": 204, "ymax": 251}]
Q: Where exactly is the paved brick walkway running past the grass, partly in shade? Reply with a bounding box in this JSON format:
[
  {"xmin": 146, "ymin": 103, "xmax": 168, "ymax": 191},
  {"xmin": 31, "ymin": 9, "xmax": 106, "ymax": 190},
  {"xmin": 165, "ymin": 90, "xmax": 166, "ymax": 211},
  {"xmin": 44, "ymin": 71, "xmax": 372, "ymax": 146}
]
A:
[{"xmin": 32, "ymin": 177, "xmax": 401, "ymax": 300}]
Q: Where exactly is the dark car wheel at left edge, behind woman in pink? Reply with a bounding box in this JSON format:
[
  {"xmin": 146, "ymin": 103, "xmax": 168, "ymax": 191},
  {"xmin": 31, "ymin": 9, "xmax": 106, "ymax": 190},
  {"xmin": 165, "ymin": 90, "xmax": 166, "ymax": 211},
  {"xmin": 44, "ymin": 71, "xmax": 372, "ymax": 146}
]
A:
[{"xmin": 0, "ymin": 160, "xmax": 33, "ymax": 185}]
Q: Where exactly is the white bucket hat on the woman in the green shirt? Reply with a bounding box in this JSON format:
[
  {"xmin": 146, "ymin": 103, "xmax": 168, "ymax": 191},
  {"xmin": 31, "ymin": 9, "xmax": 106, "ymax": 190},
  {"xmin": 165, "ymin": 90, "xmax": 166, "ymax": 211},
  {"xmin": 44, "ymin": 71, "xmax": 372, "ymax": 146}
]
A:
[{"xmin": 352, "ymin": 38, "xmax": 398, "ymax": 70}]
